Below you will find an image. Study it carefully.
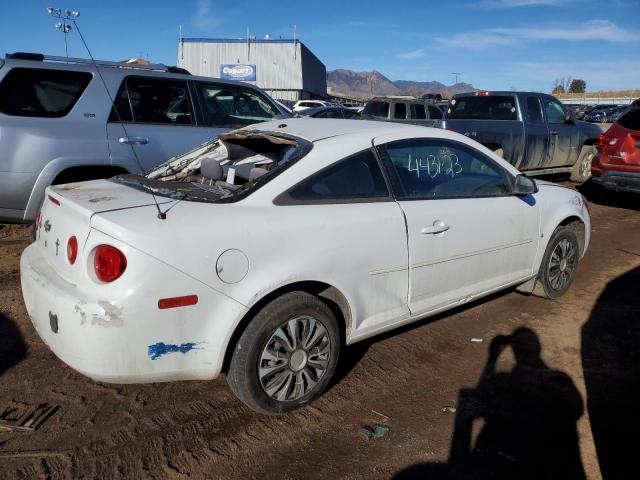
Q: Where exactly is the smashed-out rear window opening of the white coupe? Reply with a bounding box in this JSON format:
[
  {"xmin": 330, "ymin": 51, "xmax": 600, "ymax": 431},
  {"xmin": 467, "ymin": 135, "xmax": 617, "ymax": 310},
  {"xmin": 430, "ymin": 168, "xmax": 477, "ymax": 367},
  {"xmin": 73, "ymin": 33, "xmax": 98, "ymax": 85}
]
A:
[{"xmin": 111, "ymin": 130, "xmax": 313, "ymax": 203}]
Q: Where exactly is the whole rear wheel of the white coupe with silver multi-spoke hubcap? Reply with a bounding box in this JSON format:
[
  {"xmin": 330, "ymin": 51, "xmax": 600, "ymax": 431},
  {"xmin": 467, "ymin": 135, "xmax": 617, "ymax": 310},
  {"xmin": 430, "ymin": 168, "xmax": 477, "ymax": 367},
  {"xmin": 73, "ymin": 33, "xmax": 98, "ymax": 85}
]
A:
[{"xmin": 227, "ymin": 292, "xmax": 341, "ymax": 413}]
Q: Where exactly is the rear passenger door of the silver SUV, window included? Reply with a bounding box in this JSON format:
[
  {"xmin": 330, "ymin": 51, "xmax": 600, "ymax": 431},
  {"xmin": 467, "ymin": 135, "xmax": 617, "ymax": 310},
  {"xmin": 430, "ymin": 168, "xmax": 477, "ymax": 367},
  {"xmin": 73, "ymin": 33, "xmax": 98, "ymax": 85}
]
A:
[{"xmin": 107, "ymin": 76, "xmax": 216, "ymax": 170}]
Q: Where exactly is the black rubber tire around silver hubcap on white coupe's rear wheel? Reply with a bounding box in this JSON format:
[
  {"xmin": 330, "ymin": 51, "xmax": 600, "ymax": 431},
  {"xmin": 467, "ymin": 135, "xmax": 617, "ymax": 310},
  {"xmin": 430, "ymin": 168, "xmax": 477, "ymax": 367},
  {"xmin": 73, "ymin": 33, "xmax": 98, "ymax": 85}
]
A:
[{"xmin": 227, "ymin": 292, "xmax": 341, "ymax": 413}]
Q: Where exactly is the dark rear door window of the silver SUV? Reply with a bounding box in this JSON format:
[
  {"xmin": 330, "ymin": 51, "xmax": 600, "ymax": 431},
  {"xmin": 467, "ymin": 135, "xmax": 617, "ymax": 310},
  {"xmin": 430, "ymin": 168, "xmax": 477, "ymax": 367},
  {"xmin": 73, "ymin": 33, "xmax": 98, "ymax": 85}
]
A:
[{"xmin": 109, "ymin": 77, "xmax": 195, "ymax": 125}]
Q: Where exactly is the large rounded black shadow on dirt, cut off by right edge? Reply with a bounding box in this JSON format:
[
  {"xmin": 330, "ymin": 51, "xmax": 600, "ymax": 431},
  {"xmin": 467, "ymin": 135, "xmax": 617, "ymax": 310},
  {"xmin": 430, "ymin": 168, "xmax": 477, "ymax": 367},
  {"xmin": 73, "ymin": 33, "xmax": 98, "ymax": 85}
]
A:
[{"xmin": 581, "ymin": 267, "xmax": 640, "ymax": 480}]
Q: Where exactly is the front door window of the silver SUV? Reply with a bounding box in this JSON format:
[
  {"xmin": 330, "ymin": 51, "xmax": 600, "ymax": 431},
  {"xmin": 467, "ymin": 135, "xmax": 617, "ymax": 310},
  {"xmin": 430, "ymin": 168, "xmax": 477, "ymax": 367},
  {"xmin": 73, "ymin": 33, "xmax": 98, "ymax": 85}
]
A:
[{"xmin": 197, "ymin": 82, "xmax": 278, "ymax": 127}]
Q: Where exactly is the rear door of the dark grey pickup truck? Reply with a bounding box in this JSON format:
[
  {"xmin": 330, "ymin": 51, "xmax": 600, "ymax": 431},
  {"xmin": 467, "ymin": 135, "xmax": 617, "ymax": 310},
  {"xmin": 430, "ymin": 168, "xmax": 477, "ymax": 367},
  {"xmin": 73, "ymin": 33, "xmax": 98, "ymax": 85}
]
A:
[{"xmin": 516, "ymin": 95, "xmax": 549, "ymax": 170}]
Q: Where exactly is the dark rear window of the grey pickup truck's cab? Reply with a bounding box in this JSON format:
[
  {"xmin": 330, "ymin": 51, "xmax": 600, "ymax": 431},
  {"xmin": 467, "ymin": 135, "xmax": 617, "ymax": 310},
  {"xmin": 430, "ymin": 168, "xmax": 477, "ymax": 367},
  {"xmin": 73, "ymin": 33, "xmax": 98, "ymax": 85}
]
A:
[{"xmin": 446, "ymin": 95, "xmax": 518, "ymax": 120}]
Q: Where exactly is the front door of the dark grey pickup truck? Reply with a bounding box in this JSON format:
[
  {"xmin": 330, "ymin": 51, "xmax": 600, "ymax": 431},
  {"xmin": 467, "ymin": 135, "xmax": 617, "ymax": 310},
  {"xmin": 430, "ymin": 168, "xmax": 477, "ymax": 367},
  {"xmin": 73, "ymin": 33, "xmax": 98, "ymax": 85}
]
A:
[{"xmin": 543, "ymin": 97, "xmax": 578, "ymax": 167}]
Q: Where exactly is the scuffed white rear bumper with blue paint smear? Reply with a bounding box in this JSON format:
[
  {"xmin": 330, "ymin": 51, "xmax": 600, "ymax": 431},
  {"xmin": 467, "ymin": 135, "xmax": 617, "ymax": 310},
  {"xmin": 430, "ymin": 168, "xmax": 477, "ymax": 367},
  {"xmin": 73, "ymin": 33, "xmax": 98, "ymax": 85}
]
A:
[{"xmin": 20, "ymin": 244, "xmax": 246, "ymax": 383}]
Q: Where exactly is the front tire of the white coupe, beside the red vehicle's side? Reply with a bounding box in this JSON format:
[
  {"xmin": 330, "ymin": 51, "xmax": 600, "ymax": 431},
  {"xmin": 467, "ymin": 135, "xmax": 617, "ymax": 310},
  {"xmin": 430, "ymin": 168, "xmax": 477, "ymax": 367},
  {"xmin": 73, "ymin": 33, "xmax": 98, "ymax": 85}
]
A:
[{"xmin": 534, "ymin": 227, "xmax": 580, "ymax": 299}]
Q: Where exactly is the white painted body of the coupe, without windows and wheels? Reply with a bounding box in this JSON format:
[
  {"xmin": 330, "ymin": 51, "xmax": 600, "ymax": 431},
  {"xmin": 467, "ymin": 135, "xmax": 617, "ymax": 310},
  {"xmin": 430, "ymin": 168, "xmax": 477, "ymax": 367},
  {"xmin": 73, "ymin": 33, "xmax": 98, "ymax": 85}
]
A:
[{"xmin": 21, "ymin": 119, "xmax": 590, "ymax": 383}]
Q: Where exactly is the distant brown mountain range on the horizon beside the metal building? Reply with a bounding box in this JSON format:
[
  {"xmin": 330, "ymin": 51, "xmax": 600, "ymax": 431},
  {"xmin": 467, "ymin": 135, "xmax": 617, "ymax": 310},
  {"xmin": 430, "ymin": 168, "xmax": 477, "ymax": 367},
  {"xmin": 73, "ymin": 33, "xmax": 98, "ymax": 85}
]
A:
[{"xmin": 327, "ymin": 68, "xmax": 476, "ymax": 97}]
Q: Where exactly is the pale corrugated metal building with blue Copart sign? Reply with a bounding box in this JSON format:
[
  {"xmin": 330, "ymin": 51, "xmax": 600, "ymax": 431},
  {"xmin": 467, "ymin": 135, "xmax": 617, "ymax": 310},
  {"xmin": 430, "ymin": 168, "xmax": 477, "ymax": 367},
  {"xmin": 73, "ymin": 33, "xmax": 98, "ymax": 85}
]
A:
[{"xmin": 178, "ymin": 38, "xmax": 327, "ymax": 101}]
